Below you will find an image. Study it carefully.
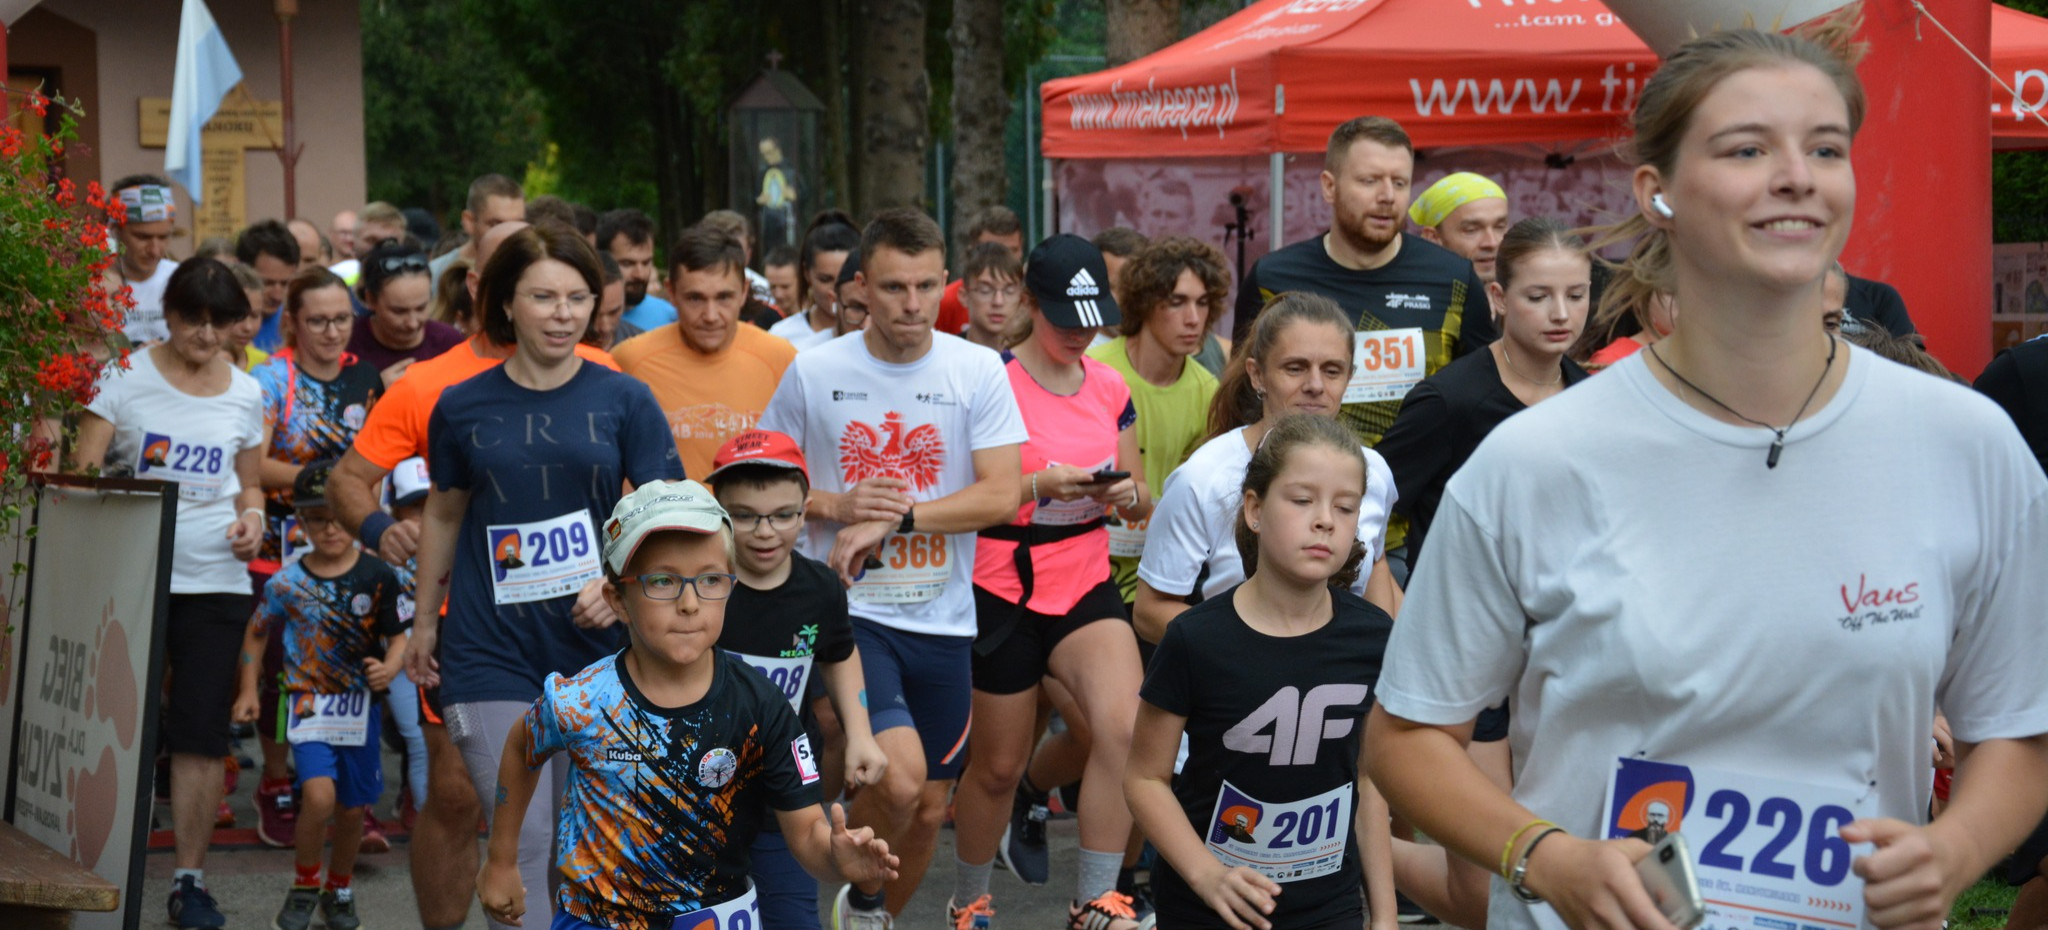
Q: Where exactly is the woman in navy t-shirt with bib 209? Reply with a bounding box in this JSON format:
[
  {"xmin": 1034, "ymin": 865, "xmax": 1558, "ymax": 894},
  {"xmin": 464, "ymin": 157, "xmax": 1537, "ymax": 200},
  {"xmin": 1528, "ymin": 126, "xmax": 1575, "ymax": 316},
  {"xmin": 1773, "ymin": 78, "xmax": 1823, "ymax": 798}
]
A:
[{"xmin": 408, "ymin": 225, "xmax": 682, "ymax": 930}]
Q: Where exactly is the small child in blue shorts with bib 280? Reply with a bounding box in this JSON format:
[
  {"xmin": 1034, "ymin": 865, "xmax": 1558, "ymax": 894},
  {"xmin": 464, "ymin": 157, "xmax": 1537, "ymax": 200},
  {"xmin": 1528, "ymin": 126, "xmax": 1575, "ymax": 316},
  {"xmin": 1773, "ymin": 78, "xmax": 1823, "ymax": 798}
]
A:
[{"xmin": 233, "ymin": 461, "xmax": 406, "ymax": 930}]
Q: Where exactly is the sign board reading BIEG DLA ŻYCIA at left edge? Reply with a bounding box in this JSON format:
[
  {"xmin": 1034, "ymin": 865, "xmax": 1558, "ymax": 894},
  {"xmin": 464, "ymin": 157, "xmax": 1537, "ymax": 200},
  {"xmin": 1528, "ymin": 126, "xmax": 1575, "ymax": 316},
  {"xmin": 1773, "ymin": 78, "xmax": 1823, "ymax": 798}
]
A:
[{"xmin": 6, "ymin": 477, "xmax": 178, "ymax": 930}]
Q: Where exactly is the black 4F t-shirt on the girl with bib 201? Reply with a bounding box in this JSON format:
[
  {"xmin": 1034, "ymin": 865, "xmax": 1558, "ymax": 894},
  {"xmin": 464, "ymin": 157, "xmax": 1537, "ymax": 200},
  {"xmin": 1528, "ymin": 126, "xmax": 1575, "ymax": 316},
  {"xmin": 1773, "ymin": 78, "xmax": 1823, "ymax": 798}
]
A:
[{"xmin": 1139, "ymin": 588, "xmax": 1395, "ymax": 930}]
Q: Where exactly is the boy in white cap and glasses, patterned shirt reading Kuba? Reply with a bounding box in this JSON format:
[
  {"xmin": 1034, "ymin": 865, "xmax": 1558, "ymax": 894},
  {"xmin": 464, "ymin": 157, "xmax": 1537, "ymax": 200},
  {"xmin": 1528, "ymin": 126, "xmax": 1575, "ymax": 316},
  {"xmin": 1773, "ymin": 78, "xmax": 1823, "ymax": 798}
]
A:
[{"xmin": 477, "ymin": 481, "xmax": 897, "ymax": 930}]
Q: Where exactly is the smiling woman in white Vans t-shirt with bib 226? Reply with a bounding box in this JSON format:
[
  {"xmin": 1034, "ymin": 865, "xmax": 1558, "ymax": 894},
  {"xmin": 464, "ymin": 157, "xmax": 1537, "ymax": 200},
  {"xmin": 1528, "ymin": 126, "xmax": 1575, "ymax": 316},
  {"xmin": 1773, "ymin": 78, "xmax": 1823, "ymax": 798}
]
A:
[{"xmin": 1366, "ymin": 16, "xmax": 2048, "ymax": 930}]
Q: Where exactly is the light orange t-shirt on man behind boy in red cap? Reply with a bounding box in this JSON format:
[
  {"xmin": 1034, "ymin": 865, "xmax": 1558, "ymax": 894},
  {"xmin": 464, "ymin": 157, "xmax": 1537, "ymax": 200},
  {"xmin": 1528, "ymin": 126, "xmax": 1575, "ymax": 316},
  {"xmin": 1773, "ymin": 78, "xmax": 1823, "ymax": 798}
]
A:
[{"xmin": 610, "ymin": 324, "xmax": 797, "ymax": 477}]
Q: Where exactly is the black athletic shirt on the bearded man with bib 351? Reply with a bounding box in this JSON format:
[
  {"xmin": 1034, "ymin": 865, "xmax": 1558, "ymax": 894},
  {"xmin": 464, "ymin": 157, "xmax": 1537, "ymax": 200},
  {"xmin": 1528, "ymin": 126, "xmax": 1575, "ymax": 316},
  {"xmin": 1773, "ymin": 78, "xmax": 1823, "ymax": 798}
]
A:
[{"xmin": 1235, "ymin": 234, "xmax": 1497, "ymax": 447}]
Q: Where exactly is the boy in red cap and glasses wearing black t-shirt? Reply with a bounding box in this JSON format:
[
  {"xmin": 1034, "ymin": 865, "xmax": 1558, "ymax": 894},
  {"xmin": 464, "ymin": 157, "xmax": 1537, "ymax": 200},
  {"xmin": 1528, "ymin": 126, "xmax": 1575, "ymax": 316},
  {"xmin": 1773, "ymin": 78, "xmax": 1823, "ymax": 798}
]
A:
[{"xmin": 707, "ymin": 430, "xmax": 889, "ymax": 930}]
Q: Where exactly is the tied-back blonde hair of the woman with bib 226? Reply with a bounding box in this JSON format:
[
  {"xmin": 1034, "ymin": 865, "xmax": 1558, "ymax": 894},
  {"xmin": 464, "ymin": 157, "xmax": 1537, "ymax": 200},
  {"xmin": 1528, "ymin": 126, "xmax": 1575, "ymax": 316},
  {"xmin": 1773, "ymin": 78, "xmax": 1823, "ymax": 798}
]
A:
[{"xmin": 1587, "ymin": 10, "xmax": 1868, "ymax": 340}]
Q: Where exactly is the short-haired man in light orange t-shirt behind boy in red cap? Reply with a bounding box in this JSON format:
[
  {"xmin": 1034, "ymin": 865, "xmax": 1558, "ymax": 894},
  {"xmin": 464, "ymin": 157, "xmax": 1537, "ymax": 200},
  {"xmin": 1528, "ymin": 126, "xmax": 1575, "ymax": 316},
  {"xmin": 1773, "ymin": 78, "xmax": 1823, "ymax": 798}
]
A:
[{"xmin": 612, "ymin": 225, "xmax": 797, "ymax": 475}]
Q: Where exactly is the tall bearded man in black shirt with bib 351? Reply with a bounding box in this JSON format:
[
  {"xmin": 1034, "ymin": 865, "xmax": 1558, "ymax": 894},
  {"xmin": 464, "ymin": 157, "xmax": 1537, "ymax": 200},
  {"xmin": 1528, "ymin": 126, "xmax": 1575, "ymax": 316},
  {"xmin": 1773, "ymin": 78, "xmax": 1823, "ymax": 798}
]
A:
[{"xmin": 1235, "ymin": 117, "xmax": 1495, "ymax": 447}]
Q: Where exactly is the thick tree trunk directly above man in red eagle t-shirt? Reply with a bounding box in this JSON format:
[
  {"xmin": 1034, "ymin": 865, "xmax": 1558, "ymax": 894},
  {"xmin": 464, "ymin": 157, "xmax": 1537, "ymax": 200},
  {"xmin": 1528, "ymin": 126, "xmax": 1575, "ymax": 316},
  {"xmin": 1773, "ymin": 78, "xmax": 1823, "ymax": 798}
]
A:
[{"xmin": 858, "ymin": 0, "xmax": 932, "ymax": 217}]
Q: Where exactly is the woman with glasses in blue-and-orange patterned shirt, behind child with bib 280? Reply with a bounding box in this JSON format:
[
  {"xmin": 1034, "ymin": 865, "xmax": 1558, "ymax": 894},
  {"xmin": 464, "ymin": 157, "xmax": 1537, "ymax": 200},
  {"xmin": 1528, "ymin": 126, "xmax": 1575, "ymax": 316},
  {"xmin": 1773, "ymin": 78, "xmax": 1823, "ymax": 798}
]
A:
[{"xmin": 250, "ymin": 266, "xmax": 389, "ymax": 852}]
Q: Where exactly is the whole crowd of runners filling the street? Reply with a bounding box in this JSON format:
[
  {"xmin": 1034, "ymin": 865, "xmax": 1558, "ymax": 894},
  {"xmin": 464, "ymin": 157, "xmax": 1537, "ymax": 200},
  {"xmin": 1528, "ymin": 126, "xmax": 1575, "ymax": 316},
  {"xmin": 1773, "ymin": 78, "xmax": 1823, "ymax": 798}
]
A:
[{"xmin": 70, "ymin": 16, "xmax": 2048, "ymax": 930}]
